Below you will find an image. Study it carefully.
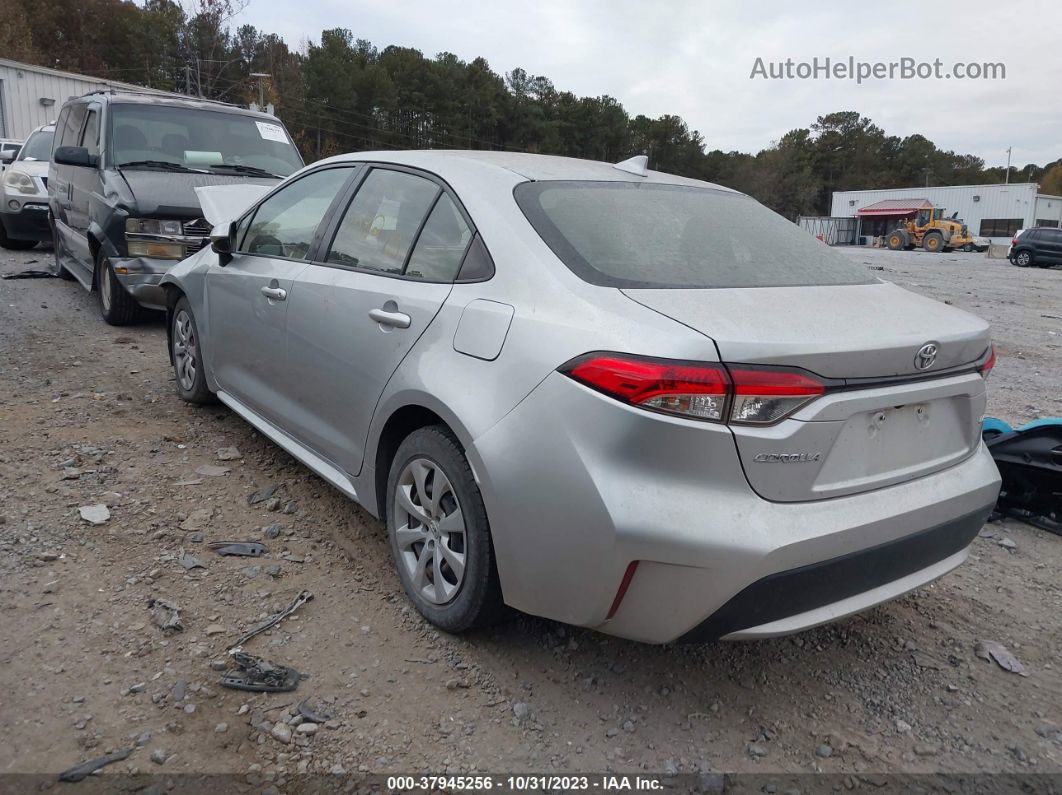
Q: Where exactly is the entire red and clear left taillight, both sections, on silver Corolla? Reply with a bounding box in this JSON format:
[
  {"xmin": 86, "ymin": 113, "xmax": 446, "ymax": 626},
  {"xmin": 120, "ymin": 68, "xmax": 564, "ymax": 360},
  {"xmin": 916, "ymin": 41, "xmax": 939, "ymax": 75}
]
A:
[{"xmin": 561, "ymin": 353, "xmax": 826, "ymax": 425}]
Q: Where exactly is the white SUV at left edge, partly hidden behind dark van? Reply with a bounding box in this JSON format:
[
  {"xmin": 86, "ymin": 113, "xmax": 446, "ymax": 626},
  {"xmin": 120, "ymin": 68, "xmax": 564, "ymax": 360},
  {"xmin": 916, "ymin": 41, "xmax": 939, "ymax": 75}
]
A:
[{"xmin": 0, "ymin": 124, "xmax": 55, "ymax": 249}]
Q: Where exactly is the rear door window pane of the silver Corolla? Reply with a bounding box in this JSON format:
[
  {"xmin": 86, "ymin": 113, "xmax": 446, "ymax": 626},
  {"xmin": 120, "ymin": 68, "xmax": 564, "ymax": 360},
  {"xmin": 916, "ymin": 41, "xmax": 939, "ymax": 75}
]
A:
[{"xmin": 326, "ymin": 169, "xmax": 440, "ymax": 274}]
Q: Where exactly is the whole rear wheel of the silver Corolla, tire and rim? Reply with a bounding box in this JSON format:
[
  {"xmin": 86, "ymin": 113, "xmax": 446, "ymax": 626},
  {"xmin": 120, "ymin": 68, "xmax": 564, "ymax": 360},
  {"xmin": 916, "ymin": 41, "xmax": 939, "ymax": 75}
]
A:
[{"xmin": 387, "ymin": 426, "xmax": 504, "ymax": 633}]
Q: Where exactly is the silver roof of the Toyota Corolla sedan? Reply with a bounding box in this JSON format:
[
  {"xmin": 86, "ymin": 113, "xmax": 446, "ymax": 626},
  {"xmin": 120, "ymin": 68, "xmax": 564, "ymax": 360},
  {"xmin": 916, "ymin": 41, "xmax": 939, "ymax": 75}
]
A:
[{"xmin": 318, "ymin": 150, "xmax": 738, "ymax": 193}]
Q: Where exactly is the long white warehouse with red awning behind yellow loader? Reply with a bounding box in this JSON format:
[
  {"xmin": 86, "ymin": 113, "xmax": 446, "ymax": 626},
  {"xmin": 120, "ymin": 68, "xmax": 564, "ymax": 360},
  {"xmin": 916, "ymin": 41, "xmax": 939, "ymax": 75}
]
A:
[{"xmin": 830, "ymin": 183, "xmax": 1062, "ymax": 243}]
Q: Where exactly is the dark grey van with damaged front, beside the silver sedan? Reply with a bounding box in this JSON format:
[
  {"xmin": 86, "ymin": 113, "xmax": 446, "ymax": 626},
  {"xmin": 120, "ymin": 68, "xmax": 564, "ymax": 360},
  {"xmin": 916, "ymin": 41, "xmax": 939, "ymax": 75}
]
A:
[{"xmin": 49, "ymin": 91, "xmax": 303, "ymax": 325}]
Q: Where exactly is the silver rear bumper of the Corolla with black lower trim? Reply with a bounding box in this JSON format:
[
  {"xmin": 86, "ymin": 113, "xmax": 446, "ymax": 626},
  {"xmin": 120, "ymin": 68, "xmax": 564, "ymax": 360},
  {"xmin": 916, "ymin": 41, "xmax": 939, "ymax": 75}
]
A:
[{"xmin": 468, "ymin": 374, "xmax": 999, "ymax": 643}]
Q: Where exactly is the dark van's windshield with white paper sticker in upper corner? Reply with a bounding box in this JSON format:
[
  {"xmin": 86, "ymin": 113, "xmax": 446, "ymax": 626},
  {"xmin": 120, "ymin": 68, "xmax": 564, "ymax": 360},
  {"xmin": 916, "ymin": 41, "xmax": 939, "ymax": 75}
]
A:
[{"xmin": 110, "ymin": 103, "xmax": 303, "ymax": 177}]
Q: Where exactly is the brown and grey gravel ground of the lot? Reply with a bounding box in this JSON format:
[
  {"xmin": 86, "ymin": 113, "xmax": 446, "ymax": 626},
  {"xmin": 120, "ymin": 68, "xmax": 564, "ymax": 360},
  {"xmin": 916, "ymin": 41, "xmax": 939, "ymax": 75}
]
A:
[{"xmin": 0, "ymin": 239, "xmax": 1062, "ymax": 792}]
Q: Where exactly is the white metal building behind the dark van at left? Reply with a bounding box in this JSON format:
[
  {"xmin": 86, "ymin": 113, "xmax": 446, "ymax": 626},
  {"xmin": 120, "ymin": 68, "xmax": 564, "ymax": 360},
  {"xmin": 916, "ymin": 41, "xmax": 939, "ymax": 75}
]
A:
[{"xmin": 0, "ymin": 58, "xmax": 167, "ymax": 140}]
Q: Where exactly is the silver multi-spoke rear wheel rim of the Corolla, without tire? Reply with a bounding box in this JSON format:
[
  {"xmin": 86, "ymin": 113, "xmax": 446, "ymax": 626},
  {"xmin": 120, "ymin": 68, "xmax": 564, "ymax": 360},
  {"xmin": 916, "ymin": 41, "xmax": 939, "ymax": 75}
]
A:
[{"xmin": 394, "ymin": 457, "xmax": 467, "ymax": 605}]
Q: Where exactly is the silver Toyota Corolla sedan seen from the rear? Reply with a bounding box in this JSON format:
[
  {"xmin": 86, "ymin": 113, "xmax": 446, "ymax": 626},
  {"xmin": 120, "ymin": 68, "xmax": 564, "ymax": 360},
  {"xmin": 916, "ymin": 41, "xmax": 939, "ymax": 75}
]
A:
[{"xmin": 162, "ymin": 151, "xmax": 999, "ymax": 643}]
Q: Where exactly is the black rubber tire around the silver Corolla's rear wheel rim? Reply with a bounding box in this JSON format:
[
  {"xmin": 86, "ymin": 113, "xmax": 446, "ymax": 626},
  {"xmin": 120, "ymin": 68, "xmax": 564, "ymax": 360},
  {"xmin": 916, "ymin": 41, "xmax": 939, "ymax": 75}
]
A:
[{"xmin": 384, "ymin": 426, "xmax": 507, "ymax": 633}]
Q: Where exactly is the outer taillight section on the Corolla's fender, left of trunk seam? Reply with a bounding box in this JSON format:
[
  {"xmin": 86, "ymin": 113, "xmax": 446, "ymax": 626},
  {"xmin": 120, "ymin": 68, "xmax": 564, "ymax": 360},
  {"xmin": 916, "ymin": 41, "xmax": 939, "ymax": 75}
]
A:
[{"xmin": 561, "ymin": 353, "xmax": 730, "ymax": 420}]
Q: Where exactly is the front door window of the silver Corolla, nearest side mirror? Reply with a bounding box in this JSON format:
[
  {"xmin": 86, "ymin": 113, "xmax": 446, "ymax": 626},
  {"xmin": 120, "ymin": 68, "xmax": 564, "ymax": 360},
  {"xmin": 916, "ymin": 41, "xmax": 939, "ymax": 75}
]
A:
[{"xmin": 239, "ymin": 169, "xmax": 350, "ymax": 259}]
